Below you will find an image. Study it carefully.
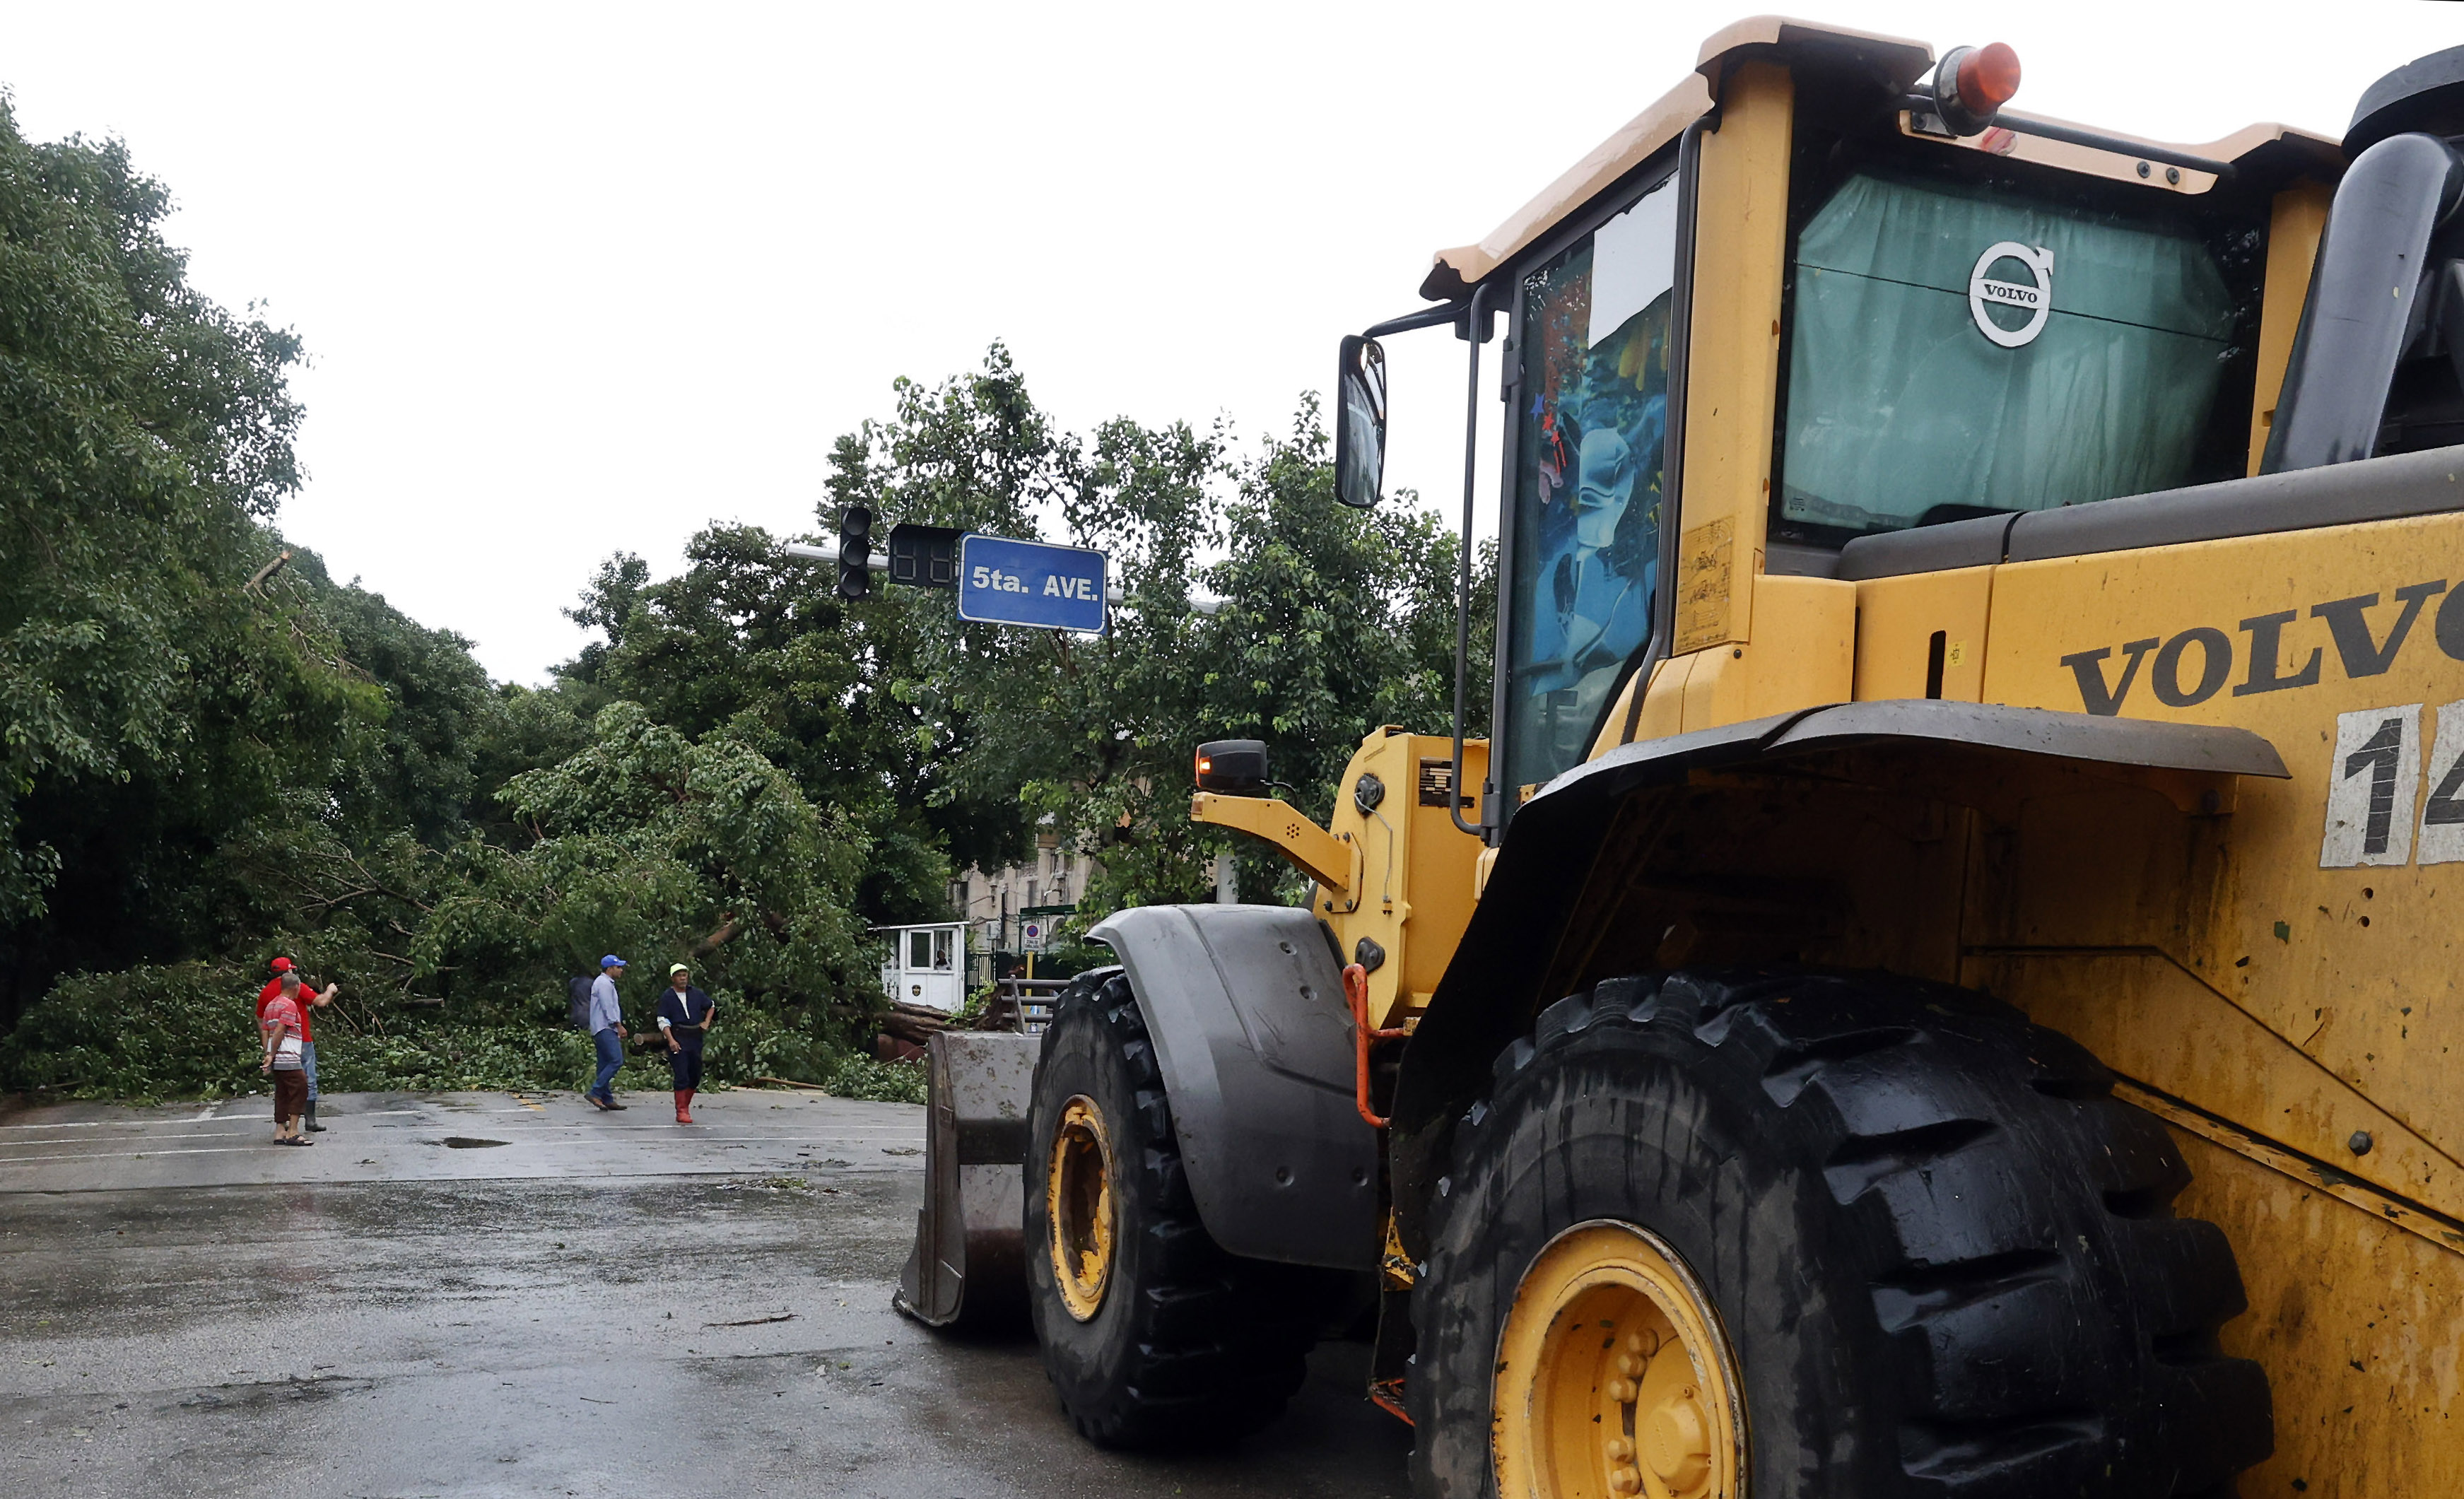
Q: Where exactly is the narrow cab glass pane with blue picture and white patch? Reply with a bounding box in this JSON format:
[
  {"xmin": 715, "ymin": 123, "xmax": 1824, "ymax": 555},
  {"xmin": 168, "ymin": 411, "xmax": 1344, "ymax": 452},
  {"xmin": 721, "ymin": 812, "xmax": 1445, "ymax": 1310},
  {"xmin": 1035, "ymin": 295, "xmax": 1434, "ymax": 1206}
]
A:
[{"xmin": 1501, "ymin": 180, "xmax": 1678, "ymax": 799}]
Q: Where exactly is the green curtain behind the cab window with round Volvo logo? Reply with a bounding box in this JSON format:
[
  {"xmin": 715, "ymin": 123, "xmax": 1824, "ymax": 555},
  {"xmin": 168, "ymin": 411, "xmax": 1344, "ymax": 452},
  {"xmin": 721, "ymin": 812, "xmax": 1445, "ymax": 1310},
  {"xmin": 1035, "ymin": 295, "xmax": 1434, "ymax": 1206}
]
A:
[{"xmin": 1781, "ymin": 175, "xmax": 2235, "ymax": 530}]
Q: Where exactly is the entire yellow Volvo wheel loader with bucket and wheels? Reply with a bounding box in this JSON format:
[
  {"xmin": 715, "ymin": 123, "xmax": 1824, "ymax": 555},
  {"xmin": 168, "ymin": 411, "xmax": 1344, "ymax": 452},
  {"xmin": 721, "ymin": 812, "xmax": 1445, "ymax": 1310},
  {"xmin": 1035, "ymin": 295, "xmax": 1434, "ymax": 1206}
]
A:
[{"xmin": 904, "ymin": 20, "xmax": 2464, "ymax": 1499}]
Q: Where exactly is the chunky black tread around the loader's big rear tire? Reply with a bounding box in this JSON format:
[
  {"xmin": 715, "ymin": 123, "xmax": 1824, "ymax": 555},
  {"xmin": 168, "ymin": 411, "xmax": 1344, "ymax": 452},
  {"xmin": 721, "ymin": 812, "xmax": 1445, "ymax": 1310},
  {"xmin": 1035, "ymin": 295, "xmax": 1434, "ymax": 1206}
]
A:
[{"xmin": 1409, "ymin": 969, "xmax": 2272, "ymax": 1499}]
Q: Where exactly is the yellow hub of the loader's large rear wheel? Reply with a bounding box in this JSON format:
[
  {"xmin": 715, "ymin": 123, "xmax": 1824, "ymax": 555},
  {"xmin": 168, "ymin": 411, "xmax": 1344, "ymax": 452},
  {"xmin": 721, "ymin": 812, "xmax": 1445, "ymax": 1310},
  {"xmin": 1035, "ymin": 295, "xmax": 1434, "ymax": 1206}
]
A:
[{"xmin": 1491, "ymin": 1223, "xmax": 1744, "ymax": 1499}]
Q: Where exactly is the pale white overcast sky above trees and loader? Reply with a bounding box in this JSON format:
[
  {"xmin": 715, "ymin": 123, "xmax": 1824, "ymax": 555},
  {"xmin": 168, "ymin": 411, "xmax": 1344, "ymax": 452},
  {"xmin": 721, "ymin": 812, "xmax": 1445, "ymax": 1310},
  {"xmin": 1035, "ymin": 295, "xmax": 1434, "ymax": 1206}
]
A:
[{"xmin": 0, "ymin": 0, "xmax": 2464, "ymax": 681}]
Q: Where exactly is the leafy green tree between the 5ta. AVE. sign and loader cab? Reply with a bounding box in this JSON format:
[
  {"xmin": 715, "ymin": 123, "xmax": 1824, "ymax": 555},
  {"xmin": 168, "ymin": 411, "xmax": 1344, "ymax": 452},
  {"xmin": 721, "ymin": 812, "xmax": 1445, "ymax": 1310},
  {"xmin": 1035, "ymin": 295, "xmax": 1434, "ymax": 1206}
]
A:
[{"xmin": 958, "ymin": 397, "xmax": 1496, "ymax": 912}]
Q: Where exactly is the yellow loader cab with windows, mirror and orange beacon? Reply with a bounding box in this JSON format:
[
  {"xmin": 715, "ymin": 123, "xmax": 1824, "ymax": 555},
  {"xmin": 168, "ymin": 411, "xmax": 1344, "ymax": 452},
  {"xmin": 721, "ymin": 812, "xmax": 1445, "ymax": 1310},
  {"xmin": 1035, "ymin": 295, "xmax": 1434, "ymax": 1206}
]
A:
[{"xmin": 1338, "ymin": 20, "xmax": 2341, "ymax": 841}]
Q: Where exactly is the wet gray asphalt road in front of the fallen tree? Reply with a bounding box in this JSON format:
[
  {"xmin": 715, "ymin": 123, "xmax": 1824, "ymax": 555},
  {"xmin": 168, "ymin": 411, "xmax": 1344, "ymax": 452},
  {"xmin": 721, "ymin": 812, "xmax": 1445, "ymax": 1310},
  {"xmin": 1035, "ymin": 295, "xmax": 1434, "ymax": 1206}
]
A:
[{"xmin": 0, "ymin": 1092, "xmax": 1409, "ymax": 1499}]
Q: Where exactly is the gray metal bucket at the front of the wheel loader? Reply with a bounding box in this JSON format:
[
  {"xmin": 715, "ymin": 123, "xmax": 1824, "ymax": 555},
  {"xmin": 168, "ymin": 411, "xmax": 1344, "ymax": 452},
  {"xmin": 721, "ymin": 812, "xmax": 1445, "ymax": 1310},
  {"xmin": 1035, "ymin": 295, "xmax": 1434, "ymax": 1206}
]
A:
[{"xmin": 892, "ymin": 1030, "xmax": 1043, "ymax": 1327}]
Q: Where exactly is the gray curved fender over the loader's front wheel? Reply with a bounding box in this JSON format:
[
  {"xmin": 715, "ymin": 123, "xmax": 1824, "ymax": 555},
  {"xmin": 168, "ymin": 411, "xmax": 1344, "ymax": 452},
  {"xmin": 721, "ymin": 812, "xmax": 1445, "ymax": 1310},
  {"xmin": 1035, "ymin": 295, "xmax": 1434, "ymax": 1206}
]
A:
[{"xmin": 1086, "ymin": 905, "xmax": 1380, "ymax": 1270}]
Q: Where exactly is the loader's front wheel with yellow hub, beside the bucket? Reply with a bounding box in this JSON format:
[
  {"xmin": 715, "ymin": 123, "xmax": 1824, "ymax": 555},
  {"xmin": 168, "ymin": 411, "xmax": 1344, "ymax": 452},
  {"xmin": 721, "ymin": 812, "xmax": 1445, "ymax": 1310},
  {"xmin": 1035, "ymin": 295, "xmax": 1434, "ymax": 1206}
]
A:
[{"xmin": 1025, "ymin": 969, "xmax": 1330, "ymax": 1447}]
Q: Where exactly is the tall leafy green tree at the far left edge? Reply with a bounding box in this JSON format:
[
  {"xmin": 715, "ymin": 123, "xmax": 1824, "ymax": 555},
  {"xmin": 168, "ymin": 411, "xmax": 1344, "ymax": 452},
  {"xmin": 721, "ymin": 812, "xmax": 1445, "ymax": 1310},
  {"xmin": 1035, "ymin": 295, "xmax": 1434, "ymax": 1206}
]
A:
[{"xmin": 0, "ymin": 101, "xmax": 322, "ymax": 956}]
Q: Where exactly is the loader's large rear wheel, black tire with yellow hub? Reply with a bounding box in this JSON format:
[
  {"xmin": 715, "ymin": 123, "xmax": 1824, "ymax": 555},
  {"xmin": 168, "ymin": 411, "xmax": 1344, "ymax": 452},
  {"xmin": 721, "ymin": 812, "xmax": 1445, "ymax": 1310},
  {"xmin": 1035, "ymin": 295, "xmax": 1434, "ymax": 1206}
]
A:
[{"xmin": 1409, "ymin": 969, "xmax": 2275, "ymax": 1499}]
